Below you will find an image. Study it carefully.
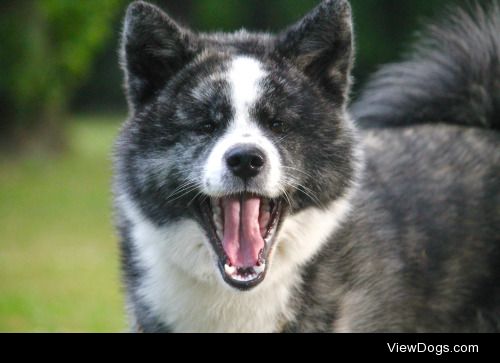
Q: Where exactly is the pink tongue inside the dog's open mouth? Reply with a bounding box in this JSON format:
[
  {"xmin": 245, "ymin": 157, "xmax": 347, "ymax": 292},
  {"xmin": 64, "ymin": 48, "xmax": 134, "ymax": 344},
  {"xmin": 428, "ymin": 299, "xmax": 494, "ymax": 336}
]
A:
[{"xmin": 222, "ymin": 196, "xmax": 264, "ymax": 268}]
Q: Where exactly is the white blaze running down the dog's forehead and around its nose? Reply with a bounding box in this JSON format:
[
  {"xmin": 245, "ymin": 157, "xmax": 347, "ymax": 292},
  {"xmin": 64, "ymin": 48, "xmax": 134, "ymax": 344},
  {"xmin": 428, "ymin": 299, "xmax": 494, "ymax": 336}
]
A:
[{"xmin": 203, "ymin": 56, "xmax": 281, "ymax": 197}]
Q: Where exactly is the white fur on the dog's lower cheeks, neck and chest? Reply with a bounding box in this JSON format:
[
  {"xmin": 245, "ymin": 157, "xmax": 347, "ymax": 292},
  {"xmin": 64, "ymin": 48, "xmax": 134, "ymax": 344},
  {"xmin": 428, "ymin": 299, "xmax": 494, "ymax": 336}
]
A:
[{"xmin": 120, "ymin": 192, "xmax": 350, "ymax": 332}]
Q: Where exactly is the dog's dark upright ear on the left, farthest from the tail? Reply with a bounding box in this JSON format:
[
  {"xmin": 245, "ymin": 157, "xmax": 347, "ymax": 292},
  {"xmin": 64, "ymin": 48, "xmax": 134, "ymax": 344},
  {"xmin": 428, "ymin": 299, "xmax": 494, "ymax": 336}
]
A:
[{"xmin": 121, "ymin": 1, "xmax": 195, "ymax": 108}]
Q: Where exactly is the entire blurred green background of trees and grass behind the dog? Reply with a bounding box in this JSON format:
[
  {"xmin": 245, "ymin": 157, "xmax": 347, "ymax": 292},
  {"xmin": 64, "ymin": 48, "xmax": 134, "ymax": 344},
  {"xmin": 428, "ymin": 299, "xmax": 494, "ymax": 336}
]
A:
[{"xmin": 0, "ymin": 0, "xmax": 463, "ymax": 332}]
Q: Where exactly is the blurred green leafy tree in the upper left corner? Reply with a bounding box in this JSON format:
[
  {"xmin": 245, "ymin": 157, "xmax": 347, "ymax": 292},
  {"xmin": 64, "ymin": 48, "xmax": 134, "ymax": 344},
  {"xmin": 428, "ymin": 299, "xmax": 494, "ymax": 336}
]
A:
[{"xmin": 0, "ymin": 0, "xmax": 123, "ymax": 154}]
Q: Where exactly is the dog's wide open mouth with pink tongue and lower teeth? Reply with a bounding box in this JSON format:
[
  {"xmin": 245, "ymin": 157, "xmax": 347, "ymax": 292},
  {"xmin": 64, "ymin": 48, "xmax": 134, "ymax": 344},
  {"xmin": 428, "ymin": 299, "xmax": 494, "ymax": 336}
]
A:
[{"xmin": 200, "ymin": 193, "xmax": 283, "ymax": 290}]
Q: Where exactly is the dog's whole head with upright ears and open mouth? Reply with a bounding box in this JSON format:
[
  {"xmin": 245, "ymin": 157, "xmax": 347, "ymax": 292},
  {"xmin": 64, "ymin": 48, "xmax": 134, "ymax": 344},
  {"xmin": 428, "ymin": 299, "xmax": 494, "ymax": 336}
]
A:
[{"xmin": 117, "ymin": 0, "xmax": 354, "ymax": 289}]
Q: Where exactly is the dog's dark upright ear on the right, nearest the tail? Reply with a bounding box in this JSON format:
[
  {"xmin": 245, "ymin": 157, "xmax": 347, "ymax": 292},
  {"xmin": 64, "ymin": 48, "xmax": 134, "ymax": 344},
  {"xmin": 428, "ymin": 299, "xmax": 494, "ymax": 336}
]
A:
[{"xmin": 275, "ymin": 0, "xmax": 353, "ymax": 102}]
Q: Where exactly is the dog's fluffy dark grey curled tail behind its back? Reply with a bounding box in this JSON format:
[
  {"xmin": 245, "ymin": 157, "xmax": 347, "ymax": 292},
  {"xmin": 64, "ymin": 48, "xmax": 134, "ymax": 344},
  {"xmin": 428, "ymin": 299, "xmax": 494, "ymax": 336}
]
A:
[{"xmin": 351, "ymin": 2, "xmax": 500, "ymax": 129}]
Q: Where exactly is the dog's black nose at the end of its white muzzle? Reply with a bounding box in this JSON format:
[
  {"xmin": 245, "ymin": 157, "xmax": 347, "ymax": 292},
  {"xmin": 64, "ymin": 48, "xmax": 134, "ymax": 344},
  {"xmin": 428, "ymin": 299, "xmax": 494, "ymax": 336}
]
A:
[{"xmin": 225, "ymin": 146, "xmax": 266, "ymax": 179}]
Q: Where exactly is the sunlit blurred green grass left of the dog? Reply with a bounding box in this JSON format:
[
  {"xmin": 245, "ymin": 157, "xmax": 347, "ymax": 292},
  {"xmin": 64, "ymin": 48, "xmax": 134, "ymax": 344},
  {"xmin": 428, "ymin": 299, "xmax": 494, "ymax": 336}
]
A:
[{"xmin": 0, "ymin": 117, "xmax": 126, "ymax": 332}]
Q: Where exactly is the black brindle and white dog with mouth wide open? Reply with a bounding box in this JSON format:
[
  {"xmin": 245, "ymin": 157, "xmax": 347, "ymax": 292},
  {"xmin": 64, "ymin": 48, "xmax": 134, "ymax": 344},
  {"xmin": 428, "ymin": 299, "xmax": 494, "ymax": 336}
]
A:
[{"xmin": 113, "ymin": 0, "xmax": 500, "ymax": 332}]
